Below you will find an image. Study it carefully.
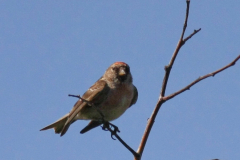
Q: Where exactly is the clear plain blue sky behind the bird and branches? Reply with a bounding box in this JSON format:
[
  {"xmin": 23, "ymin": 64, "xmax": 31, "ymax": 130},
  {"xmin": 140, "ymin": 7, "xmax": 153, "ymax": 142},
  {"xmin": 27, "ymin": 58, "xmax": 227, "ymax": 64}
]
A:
[{"xmin": 0, "ymin": 0, "xmax": 240, "ymax": 160}]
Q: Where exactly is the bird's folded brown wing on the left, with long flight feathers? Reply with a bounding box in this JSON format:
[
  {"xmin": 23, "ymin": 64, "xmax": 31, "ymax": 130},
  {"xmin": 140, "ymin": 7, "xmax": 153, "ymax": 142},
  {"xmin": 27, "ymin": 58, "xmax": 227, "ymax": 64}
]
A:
[{"xmin": 61, "ymin": 78, "xmax": 110, "ymax": 136}]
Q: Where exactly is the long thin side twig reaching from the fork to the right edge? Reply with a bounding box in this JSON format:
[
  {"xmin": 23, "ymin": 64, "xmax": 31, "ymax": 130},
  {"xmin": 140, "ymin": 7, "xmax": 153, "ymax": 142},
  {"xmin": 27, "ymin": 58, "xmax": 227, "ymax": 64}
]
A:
[{"xmin": 162, "ymin": 55, "xmax": 240, "ymax": 101}]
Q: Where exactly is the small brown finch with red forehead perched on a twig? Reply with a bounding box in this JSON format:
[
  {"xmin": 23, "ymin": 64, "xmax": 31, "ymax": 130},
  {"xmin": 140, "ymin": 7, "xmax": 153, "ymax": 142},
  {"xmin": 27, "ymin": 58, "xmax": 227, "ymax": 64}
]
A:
[{"xmin": 40, "ymin": 62, "xmax": 138, "ymax": 136}]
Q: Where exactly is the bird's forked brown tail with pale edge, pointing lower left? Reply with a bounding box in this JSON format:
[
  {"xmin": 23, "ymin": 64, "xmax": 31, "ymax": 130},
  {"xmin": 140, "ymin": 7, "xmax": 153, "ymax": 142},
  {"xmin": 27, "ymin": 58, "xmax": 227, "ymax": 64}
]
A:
[{"xmin": 40, "ymin": 113, "xmax": 69, "ymax": 134}]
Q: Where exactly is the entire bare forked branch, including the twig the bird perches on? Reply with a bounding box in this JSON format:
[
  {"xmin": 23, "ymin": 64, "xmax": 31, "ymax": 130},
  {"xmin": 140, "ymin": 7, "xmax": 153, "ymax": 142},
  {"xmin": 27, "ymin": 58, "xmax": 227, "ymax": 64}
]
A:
[{"xmin": 73, "ymin": 0, "xmax": 240, "ymax": 160}]
